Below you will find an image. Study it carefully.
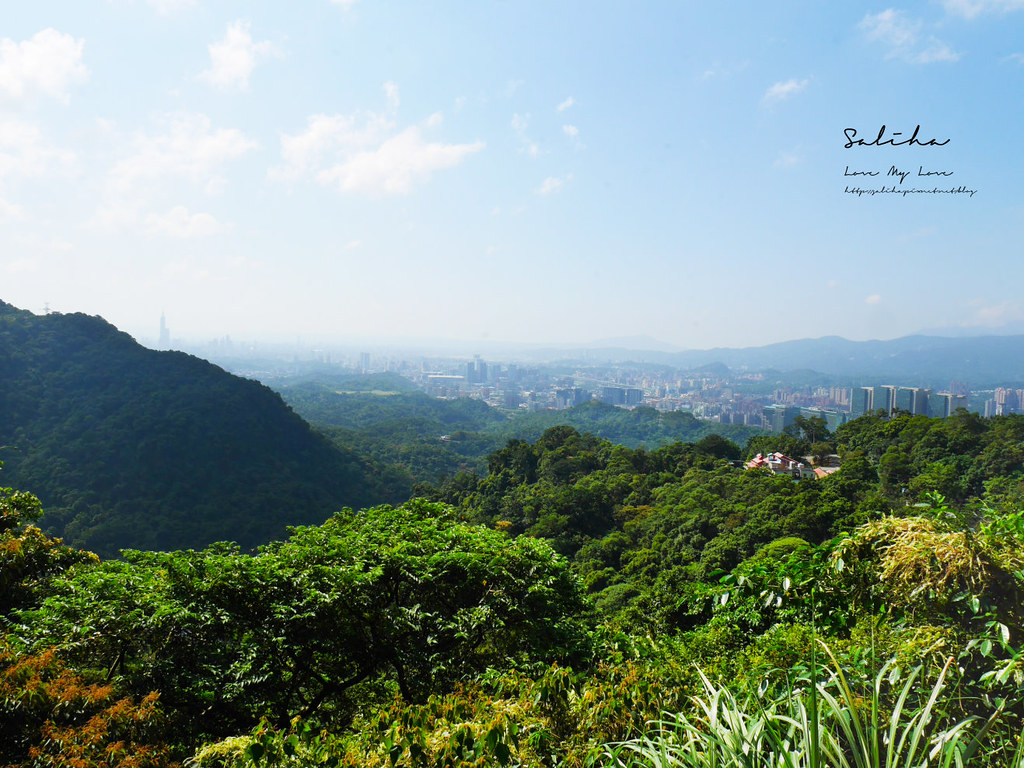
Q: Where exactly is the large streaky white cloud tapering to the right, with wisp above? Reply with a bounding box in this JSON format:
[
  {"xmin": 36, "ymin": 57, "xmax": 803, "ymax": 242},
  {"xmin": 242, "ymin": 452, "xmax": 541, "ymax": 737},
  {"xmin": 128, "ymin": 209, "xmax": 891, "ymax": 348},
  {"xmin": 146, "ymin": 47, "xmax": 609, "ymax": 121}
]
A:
[{"xmin": 270, "ymin": 83, "xmax": 483, "ymax": 196}]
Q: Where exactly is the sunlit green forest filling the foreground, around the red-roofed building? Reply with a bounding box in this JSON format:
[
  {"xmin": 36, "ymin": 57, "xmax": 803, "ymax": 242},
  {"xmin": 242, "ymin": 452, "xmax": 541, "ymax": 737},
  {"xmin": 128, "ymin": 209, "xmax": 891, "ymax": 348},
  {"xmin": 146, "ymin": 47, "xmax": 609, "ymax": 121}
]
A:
[{"xmin": 0, "ymin": 412, "xmax": 1024, "ymax": 768}]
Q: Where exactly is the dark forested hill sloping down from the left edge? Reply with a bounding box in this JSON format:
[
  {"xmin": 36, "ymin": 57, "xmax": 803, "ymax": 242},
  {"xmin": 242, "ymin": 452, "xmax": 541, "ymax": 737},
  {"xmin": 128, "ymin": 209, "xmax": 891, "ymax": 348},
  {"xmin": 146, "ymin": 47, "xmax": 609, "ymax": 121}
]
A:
[{"xmin": 0, "ymin": 302, "xmax": 393, "ymax": 555}]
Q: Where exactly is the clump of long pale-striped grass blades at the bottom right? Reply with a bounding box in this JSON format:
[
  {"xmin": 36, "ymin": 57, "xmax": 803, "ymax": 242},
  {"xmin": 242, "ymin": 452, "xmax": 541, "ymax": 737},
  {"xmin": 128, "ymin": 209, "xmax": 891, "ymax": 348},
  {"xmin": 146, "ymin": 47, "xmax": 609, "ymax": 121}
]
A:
[{"xmin": 604, "ymin": 648, "xmax": 999, "ymax": 768}]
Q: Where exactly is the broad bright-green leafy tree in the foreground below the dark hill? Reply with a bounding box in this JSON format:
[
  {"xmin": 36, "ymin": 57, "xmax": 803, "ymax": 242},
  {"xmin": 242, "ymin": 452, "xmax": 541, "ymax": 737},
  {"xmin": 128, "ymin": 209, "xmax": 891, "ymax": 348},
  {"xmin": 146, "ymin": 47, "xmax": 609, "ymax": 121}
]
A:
[{"xmin": 23, "ymin": 501, "xmax": 586, "ymax": 739}]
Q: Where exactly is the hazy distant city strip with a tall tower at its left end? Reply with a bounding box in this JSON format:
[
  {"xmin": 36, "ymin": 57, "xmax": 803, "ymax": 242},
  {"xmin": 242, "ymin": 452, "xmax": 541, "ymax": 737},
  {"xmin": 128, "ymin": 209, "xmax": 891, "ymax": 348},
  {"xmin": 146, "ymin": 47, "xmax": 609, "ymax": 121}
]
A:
[{"xmin": 157, "ymin": 323, "xmax": 1024, "ymax": 433}]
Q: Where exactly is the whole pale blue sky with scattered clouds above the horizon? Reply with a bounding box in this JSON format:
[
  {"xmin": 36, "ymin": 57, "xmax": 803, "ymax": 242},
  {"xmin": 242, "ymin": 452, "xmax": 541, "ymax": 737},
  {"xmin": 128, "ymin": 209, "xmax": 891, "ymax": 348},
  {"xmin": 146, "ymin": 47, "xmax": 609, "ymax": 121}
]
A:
[{"xmin": 0, "ymin": 0, "xmax": 1024, "ymax": 348}]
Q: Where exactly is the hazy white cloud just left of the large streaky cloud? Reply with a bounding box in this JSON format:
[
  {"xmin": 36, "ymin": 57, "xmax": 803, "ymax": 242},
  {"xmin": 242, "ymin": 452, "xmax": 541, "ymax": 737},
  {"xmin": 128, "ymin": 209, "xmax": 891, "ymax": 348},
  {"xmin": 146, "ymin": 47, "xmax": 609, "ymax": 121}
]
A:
[{"xmin": 111, "ymin": 114, "xmax": 257, "ymax": 194}]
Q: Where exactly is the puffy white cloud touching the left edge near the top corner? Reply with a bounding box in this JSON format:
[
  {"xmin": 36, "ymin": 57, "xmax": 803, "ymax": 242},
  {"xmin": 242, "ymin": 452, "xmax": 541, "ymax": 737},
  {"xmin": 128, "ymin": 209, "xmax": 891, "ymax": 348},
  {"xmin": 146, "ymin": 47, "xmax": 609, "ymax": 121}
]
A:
[{"xmin": 0, "ymin": 29, "xmax": 89, "ymax": 102}]
